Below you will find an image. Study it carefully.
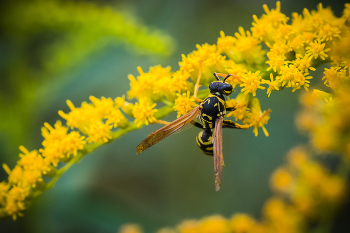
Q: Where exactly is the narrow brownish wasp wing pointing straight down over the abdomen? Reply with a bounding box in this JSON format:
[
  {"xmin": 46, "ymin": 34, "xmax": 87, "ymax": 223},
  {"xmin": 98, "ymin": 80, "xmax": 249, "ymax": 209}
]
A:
[{"xmin": 213, "ymin": 116, "xmax": 224, "ymax": 191}]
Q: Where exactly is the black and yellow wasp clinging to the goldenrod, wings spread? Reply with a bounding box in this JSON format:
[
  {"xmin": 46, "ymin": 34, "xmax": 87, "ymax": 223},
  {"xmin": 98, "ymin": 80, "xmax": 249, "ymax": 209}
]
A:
[{"xmin": 136, "ymin": 73, "xmax": 249, "ymax": 191}]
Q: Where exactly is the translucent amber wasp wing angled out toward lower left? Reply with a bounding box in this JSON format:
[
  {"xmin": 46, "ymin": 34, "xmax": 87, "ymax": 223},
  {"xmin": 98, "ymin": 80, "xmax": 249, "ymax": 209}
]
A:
[{"xmin": 136, "ymin": 105, "xmax": 201, "ymax": 154}]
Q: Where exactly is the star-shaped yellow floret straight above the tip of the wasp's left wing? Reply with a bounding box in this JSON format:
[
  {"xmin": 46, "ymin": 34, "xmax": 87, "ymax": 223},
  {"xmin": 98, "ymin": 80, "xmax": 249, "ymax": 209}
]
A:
[{"xmin": 132, "ymin": 98, "xmax": 158, "ymax": 127}]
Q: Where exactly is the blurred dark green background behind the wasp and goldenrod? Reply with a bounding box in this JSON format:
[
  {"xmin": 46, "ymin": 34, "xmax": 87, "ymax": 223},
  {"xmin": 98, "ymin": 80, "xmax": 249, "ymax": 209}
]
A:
[{"xmin": 0, "ymin": 0, "xmax": 344, "ymax": 233}]
